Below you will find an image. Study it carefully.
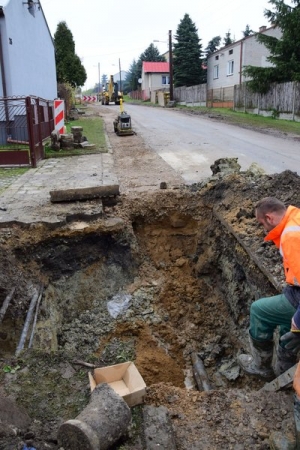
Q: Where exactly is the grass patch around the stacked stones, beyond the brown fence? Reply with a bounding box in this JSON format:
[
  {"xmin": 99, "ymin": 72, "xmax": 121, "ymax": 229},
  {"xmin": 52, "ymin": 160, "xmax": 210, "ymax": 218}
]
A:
[{"xmin": 45, "ymin": 117, "xmax": 108, "ymax": 158}]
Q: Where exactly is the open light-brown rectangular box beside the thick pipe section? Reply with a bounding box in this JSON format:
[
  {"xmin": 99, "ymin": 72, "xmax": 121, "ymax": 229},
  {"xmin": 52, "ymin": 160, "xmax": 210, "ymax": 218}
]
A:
[{"xmin": 89, "ymin": 361, "xmax": 146, "ymax": 407}]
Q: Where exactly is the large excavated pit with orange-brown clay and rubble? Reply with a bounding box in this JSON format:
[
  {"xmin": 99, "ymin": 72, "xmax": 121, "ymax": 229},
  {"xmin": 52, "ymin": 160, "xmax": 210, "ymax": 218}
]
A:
[{"xmin": 0, "ymin": 171, "xmax": 298, "ymax": 448}]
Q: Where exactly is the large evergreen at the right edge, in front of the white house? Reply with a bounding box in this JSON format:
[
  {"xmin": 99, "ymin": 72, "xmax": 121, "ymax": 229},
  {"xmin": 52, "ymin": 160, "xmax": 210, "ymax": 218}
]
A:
[{"xmin": 243, "ymin": 0, "xmax": 300, "ymax": 93}]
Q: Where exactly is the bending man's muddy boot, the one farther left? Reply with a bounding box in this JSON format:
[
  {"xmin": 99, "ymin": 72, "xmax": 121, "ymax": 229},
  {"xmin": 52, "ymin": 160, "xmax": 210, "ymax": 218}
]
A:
[{"xmin": 237, "ymin": 335, "xmax": 274, "ymax": 380}]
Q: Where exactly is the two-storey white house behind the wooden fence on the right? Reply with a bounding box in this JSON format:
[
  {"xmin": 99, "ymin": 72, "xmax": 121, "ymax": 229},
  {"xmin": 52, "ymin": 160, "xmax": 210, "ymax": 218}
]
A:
[{"xmin": 207, "ymin": 27, "xmax": 282, "ymax": 89}]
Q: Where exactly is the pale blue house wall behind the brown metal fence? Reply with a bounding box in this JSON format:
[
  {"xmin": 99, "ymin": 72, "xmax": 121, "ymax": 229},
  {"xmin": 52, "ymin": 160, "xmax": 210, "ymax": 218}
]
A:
[{"xmin": 0, "ymin": 0, "xmax": 57, "ymax": 100}]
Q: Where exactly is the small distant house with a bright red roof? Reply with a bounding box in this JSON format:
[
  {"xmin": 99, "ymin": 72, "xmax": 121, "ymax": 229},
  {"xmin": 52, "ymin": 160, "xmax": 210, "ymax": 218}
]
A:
[{"xmin": 141, "ymin": 61, "xmax": 170, "ymax": 100}]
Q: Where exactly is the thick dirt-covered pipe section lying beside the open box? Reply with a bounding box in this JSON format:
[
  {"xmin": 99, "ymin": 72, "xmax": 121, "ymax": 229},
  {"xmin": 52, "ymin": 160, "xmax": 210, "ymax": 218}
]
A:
[{"xmin": 57, "ymin": 383, "xmax": 131, "ymax": 450}]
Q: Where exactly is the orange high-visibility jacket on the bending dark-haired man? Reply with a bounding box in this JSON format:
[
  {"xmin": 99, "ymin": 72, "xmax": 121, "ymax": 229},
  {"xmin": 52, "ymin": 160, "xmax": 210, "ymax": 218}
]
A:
[{"xmin": 264, "ymin": 206, "xmax": 300, "ymax": 286}]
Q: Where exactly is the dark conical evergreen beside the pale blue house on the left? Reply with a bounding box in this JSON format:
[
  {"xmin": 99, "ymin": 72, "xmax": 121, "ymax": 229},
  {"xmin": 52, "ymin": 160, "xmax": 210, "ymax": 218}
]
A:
[{"xmin": 54, "ymin": 22, "xmax": 87, "ymax": 87}]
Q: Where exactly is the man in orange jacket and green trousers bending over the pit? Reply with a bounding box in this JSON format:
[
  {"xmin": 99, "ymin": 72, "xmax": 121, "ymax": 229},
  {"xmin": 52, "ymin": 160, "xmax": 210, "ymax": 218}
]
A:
[{"xmin": 238, "ymin": 197, "xmax": 300, "ymax": 379}]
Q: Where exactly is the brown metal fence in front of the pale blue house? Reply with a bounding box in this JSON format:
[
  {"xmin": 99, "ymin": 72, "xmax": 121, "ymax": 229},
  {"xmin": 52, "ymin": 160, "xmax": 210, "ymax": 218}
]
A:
[{"xmin": 0, "ymin": 96, "xmax": 54, "ymax": 167}]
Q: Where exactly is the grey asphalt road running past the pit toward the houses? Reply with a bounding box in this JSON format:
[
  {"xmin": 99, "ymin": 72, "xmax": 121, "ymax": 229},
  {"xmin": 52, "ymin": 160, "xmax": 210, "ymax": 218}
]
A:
[{"xmin": 125, "ymin": 104, "xmax": 300, "ymax": 184}]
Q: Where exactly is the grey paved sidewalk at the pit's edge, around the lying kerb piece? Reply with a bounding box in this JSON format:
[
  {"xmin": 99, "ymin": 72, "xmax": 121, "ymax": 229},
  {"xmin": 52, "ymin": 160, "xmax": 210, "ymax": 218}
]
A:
[{"xmin": 0, "ymin": 151, "xmax": 119, "ymax": 227}]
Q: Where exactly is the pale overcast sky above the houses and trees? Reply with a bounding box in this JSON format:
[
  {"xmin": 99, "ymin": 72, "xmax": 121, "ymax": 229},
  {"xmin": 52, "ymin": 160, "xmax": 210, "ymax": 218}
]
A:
[{"xmin": 41, "ymin": 0, "xmax": 278, "ymax": 89}]
